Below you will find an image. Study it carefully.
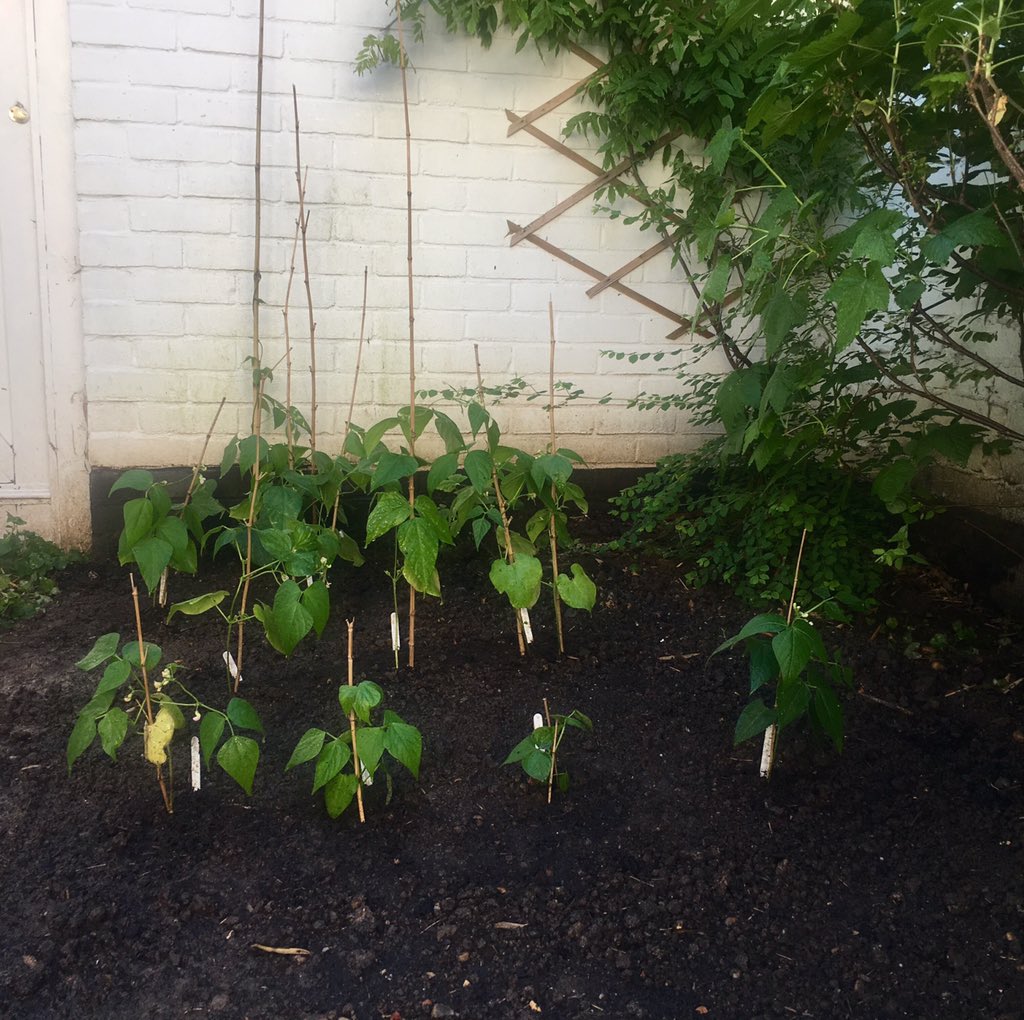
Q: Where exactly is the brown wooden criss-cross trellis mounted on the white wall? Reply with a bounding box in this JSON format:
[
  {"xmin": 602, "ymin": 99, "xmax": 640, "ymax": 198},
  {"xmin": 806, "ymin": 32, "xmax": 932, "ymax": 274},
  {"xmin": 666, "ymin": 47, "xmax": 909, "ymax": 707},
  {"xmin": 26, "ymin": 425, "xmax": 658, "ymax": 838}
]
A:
[{"xmin": 505, "ymin": 44, "xmax": 713, "ymax": 340}]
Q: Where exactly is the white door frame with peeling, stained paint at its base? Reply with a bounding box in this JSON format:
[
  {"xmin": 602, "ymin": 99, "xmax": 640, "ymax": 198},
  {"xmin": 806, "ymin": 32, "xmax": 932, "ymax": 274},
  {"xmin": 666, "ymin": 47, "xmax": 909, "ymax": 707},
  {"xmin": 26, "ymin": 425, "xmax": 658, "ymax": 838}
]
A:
[{"xmin": 0, "ymin": 0, "xmax": 91, "ymax": 549}]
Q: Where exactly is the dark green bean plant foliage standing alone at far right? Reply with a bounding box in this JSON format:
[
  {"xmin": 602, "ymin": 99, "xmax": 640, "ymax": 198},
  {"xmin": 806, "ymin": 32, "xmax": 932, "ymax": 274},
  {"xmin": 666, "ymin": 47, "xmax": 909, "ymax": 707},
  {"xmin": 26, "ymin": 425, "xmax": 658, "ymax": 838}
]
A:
[{"xmin": 714, "ymin": 612, "xmax": 852, "ymax": 752}]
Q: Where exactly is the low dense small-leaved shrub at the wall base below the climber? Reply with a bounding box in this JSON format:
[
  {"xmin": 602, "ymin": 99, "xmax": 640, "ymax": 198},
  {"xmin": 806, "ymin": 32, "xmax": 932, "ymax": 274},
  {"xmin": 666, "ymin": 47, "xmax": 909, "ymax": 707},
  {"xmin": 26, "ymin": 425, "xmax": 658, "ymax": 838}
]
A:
[{"xmin": 611, "ymin": 448, "xmax": 929, "ymax": 617}]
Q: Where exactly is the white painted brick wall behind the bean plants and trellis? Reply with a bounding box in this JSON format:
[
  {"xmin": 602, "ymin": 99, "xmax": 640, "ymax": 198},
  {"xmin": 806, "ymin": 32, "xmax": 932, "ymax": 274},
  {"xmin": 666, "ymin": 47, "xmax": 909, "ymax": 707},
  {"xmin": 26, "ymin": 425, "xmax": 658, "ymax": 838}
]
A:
[{"xmin": 71, "ymin": 0, "xmax": 720, "ymax": 466}]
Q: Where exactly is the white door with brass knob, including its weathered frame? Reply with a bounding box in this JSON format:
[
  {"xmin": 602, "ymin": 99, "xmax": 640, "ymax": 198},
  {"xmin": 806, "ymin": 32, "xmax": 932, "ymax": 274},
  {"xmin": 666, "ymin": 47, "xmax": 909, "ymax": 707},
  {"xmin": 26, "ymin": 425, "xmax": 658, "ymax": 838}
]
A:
[{"xmin": 0, "ymin": 0, "xmax": 88, "ymax": 546}]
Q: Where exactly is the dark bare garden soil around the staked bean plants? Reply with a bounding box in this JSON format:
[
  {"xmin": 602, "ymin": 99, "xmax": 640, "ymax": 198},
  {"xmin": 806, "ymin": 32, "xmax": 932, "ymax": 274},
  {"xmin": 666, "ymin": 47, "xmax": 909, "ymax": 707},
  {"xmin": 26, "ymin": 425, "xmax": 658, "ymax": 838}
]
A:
[{"xmin": 0, "ymin": 518, "xmax": 1024, "ymax": 1020}]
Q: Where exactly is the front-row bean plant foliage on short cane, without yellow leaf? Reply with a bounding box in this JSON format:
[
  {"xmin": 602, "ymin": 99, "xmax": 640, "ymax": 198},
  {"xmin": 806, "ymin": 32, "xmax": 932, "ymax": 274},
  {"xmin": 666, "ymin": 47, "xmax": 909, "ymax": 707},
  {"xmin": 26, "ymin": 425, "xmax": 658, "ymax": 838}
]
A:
[{"xmin": 285, "ymin": 680, "xmax": 423, "ymax": 818}]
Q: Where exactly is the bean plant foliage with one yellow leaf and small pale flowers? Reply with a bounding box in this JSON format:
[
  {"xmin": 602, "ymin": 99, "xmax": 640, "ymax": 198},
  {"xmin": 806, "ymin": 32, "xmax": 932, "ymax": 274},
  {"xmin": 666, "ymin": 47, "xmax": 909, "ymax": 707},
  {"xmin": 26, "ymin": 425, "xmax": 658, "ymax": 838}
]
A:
[{"xmin": 67, "ymin": 632, "xmax": 263, "ymax": 795}]
